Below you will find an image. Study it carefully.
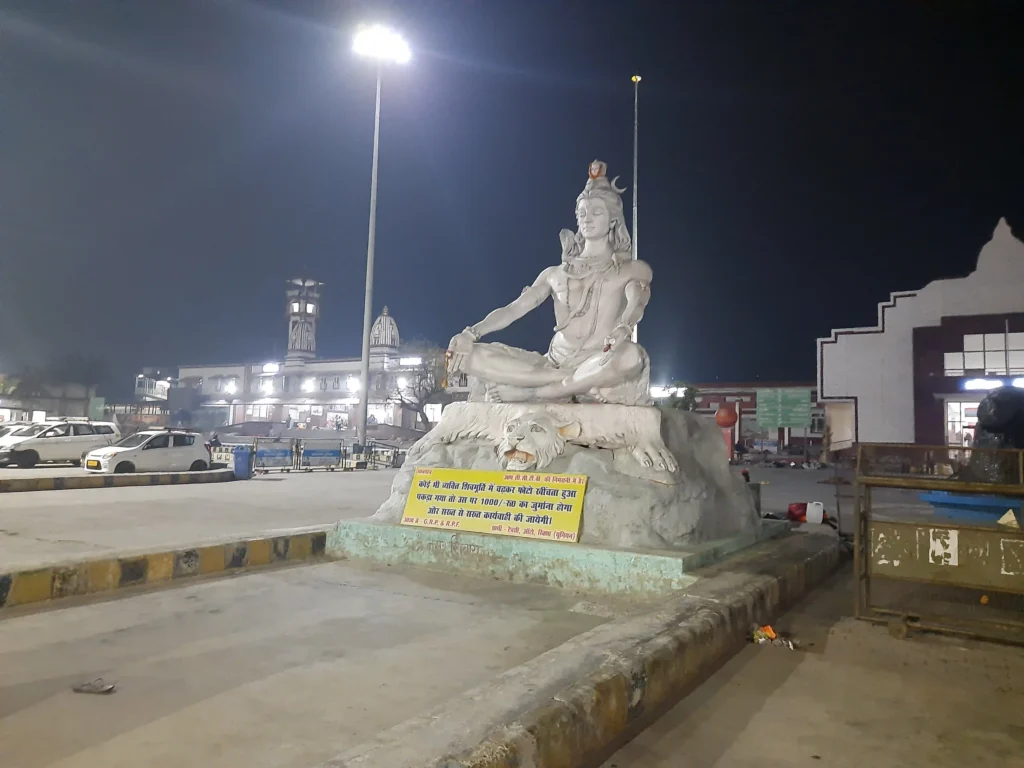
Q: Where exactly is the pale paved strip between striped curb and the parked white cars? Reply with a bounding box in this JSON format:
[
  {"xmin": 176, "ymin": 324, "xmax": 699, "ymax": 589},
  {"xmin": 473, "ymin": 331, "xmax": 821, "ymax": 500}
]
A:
[{"xmin": 0, "ymin": 470, "xmax": 394, "ymax": 571}]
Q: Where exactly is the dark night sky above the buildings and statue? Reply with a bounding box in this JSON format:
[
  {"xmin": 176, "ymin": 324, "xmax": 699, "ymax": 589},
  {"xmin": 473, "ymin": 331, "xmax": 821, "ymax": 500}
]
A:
[{"xmin": 0, "ymin": 0, "xmax": 1024, "ymax": 397}]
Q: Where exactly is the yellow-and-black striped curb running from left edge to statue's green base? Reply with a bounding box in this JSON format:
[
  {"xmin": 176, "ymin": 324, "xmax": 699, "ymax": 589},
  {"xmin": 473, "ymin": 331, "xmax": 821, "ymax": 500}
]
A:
[{"xmin": 0, "ymin": 530, "xmax": 327, "ymax": 609}]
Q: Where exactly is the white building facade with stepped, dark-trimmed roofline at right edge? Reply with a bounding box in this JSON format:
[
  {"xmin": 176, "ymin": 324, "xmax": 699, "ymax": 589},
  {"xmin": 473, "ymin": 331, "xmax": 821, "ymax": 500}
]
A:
[{"xmin": 817, "ymin": 219, "xmax": 1024, "ymax": 450}]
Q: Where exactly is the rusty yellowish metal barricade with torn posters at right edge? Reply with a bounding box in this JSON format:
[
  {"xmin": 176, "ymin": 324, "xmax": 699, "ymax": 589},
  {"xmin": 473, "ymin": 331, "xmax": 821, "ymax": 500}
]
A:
[{"xmin": 854, "ymin": 443, "xmax": 1024, "ymax": 643}]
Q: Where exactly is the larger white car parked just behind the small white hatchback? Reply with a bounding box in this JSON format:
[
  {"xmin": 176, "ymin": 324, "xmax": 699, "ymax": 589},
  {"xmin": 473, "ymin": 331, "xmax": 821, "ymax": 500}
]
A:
[{"xmin": 0, "ymin": 419, "xmax": 121, "ymax": 469}]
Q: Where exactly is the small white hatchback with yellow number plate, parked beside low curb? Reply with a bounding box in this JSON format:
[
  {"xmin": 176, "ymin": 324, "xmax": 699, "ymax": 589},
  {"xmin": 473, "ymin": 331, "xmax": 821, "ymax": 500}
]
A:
[{"xmin": 84, "ymin": 428, "xmax": 210, "ymax": 474}]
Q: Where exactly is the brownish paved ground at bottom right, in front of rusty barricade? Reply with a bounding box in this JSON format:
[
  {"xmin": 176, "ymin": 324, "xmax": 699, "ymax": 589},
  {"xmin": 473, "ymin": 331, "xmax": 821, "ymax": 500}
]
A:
[{"xmin": 603, "ymin": 572, "xmax": 1024, "ymax": 768}]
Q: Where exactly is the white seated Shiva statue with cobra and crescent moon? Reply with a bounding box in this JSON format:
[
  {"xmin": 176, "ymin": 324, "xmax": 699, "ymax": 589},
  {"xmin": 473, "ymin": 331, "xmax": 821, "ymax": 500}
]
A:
[{"xmin": 447, "ymin": 160, "xmax": 652, "ymax": 406}]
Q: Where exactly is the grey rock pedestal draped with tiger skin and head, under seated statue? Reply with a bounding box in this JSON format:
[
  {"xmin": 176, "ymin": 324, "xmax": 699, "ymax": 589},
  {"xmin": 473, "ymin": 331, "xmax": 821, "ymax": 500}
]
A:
[{"xmin": 374, "ymin": 402, "xmax": 760, "ymax": 550}]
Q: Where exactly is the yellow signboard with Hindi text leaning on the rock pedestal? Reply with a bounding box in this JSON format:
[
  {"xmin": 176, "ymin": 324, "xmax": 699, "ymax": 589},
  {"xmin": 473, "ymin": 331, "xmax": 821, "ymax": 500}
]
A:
[{"xmin": 401, "ymin": 467, "xmax": 587, "ymax": 542}]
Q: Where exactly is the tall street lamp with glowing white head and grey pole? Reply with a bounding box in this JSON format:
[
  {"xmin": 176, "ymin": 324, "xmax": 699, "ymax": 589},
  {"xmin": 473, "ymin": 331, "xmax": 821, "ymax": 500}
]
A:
[{"xmin": 350, "ymin": 25, "xmax": 413, "ymax": 445}]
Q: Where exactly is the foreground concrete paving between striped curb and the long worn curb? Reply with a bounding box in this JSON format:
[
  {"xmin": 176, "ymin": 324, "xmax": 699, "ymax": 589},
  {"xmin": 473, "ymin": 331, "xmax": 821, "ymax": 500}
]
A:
[{"xmin": 0, "ymin": 563, "xmax": 606, "ymax": 768}]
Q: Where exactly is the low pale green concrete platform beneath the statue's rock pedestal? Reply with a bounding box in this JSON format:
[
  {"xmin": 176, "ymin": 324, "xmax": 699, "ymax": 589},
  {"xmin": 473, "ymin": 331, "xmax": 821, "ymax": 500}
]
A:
[{"xmin": 327, "ymin": 520, "xmax": 791, "ymax": 594}]
